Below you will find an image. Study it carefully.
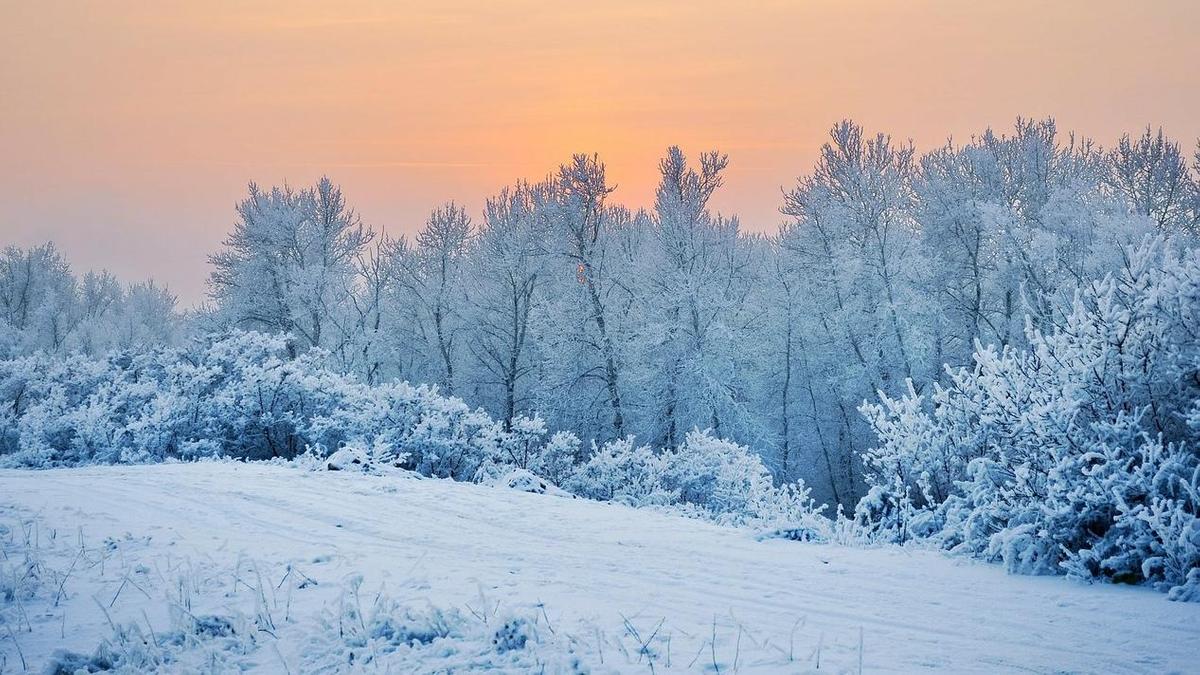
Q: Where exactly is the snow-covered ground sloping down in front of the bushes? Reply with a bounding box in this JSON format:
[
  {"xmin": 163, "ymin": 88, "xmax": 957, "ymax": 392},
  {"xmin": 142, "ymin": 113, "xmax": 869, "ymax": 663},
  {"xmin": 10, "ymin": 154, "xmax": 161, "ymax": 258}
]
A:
[{"xmin": 0, "ymin": 462, "xmax": 1200, "ymax": 673}]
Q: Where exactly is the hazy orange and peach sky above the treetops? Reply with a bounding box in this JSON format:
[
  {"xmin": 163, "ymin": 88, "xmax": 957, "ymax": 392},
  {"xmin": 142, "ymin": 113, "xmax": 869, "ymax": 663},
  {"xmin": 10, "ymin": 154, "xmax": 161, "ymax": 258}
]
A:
[{"xmin": 0, "ymin": 0, "xmax": 1200, "ymax": 306}]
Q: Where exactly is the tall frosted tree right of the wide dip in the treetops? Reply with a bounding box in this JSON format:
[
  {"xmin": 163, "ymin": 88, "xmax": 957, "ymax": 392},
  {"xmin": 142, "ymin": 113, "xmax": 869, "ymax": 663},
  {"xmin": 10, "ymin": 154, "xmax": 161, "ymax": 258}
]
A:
[{"xmin": 782, "ymin": 121, "xmax": 921, "ymax": 502}]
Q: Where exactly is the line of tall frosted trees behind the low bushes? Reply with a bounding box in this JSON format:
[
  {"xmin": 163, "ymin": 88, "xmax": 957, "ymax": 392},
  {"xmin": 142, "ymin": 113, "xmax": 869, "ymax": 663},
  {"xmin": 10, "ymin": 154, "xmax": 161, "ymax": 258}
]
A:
[{"xmin": 0, "ymin": 120, "xmax": 1200, "ymax": 506}]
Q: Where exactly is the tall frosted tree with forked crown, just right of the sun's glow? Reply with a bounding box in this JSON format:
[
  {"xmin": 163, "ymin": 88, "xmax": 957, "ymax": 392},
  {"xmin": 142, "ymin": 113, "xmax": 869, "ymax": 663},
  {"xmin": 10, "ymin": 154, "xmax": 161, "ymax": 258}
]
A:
[{"xmin": 637, "ymin": 147, "xmax": 752, "ymax": 447}]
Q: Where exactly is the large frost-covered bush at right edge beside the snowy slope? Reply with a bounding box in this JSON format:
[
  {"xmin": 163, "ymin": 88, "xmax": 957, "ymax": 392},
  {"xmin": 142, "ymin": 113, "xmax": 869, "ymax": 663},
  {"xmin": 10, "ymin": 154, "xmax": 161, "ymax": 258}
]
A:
[{"xmin": 857, "ymin": 241, "xmax": 1200, "ymax": 599}]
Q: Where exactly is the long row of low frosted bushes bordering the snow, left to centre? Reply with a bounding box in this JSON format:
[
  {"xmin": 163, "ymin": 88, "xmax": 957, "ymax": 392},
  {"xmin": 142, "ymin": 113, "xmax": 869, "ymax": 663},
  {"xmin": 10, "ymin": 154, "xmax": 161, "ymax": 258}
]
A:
[{"xmin": 0, "ymin": 331, "xmax": 820, "ymax": 530}]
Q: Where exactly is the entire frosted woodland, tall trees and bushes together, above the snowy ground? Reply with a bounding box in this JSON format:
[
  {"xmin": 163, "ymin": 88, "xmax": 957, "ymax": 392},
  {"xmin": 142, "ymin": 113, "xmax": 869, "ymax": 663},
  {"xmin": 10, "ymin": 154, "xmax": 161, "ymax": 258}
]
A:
[{"xmin": 0, "ymin": 119, "xmax": 1200, "ymax": 612}]
